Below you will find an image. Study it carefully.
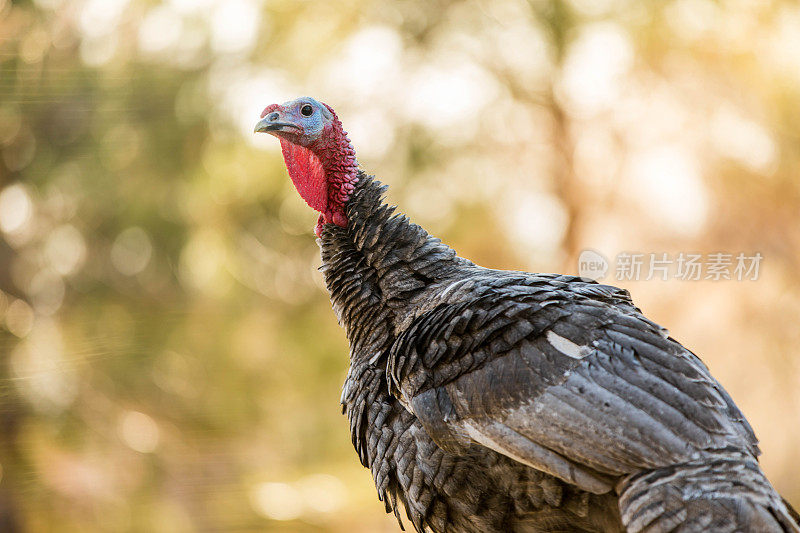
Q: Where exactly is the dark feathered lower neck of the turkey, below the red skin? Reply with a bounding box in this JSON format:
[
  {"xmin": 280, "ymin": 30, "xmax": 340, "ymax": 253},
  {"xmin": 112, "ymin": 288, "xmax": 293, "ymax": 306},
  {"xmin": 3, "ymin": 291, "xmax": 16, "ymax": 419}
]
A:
[{"xmin": 317, "ymin": 171, "xmax": 471, "ymax": 363}]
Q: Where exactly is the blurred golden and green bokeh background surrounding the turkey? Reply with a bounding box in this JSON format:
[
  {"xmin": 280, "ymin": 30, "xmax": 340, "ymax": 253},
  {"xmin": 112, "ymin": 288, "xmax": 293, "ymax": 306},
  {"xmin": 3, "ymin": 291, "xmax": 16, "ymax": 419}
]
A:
[{"xmin": 0, "ymin": 0, "xmax": 800, "ymax": 532}]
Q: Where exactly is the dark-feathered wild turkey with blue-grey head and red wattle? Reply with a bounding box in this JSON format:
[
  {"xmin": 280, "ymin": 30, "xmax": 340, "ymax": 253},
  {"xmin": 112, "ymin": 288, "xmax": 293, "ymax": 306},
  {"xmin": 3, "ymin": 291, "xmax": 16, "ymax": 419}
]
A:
[{"xmin": 255, "ymin": 98, "xmax": 800, "ymax": 532}]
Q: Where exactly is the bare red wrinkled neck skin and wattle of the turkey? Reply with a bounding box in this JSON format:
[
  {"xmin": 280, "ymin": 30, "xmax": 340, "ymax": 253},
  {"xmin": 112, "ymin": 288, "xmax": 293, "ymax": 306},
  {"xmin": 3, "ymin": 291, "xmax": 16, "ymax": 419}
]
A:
[{"xmin": 281, "ymin": 107, "xmax": 358, "ymax": 236}]
